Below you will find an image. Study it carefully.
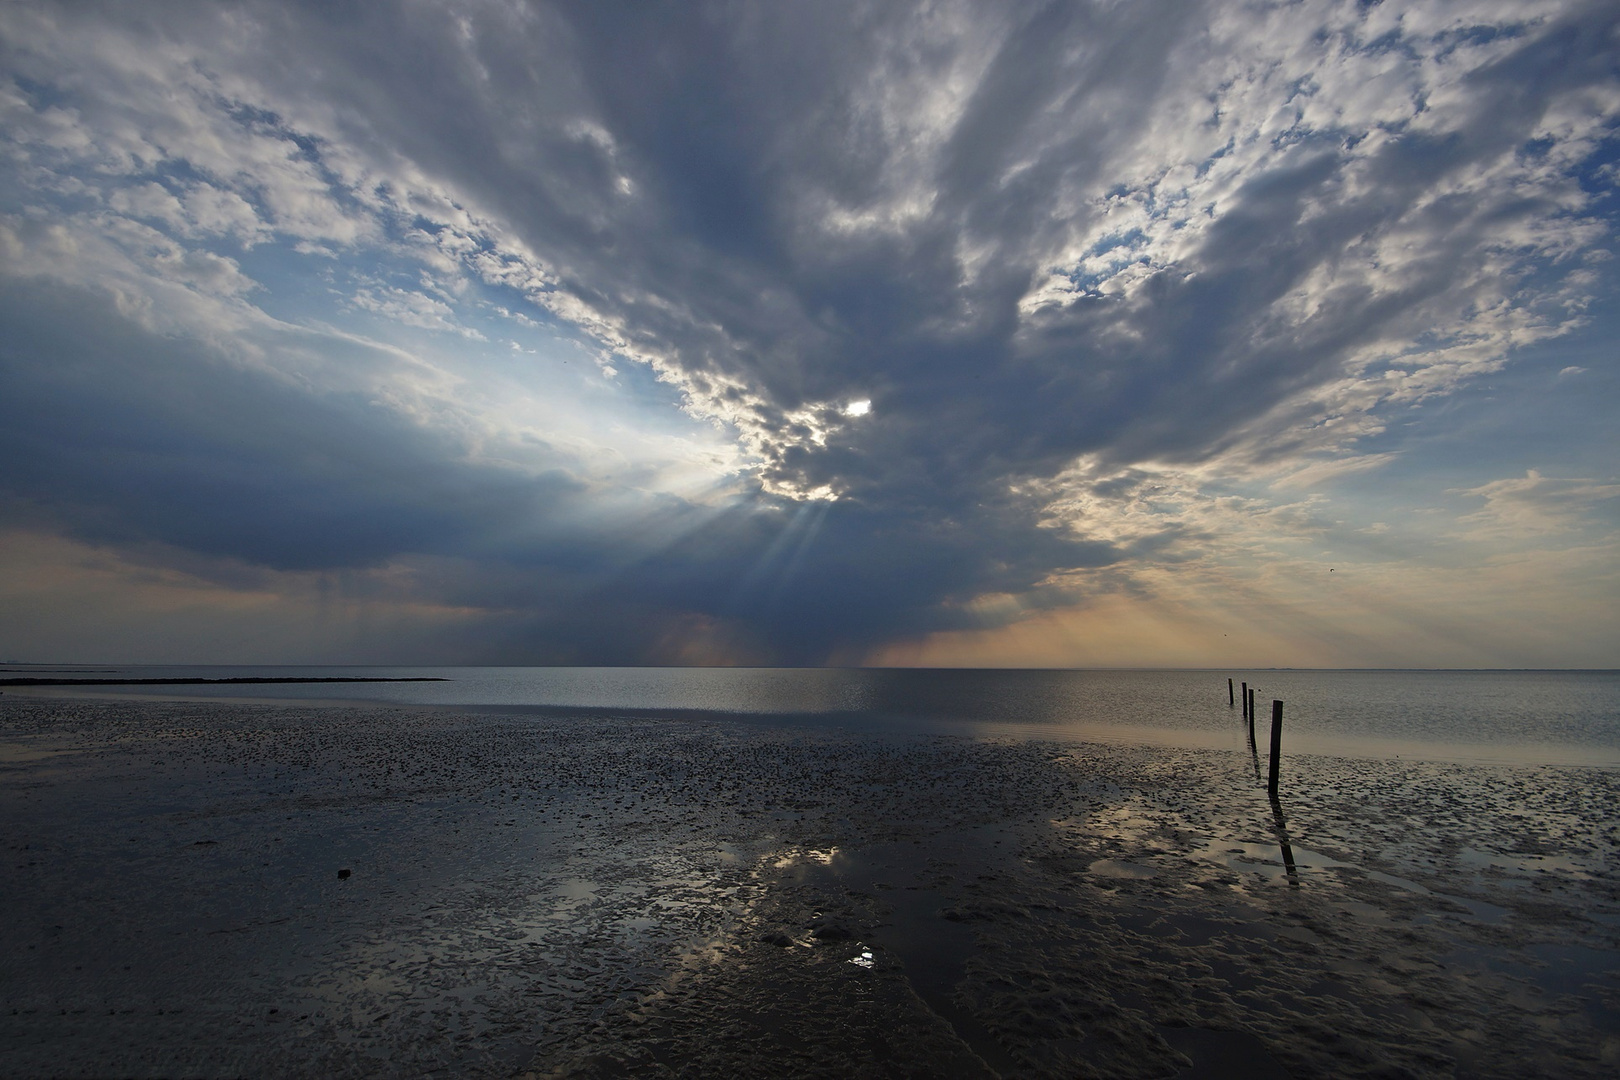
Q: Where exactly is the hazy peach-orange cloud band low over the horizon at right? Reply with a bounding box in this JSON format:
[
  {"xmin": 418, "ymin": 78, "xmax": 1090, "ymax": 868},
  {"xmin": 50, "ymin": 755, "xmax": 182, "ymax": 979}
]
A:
[{"xmin": 863, "ymin": 544, "xmax": 1620, "ymax": 669}]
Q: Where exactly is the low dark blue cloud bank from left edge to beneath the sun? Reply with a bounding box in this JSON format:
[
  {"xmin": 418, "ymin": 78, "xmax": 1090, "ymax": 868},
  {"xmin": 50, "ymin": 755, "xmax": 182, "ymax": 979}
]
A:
[{"xmin": 0, "ymin": 265, "xmax": 1110, "ymax": 662}]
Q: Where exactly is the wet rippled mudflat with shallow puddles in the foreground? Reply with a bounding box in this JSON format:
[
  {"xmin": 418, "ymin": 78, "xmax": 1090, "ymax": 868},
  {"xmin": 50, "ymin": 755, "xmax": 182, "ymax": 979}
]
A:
[{"xmin": 0, "ymin": 696, "xmax": 1620, "ymax": 1077}]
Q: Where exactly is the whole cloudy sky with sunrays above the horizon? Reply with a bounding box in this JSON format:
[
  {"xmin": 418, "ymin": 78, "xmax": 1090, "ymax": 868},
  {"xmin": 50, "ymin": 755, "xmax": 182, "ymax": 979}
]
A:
[{"xmin": 0, "ymin": 0, "xmax": 1620, "ymax": 667}]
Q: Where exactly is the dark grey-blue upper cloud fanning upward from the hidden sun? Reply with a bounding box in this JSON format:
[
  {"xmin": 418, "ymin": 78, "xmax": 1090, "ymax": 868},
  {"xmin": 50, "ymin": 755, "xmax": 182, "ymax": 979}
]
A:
[{"xmin": 212, "ymin": 3, "xmax": 1617, "ymax": 495}]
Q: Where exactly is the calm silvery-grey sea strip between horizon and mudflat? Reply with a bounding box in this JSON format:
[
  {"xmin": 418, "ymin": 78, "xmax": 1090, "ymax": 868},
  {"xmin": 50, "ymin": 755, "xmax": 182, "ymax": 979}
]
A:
[{"xmin": 0, "ymin": 665, "xmax": 1620, "ymax": 767}]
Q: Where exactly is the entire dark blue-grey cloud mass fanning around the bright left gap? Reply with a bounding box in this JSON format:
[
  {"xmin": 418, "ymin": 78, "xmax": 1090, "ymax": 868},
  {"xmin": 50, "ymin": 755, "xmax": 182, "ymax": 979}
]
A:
[{"xmin": 0, "ymin": 3, "xmax": 1620, "ymax": 662}]
